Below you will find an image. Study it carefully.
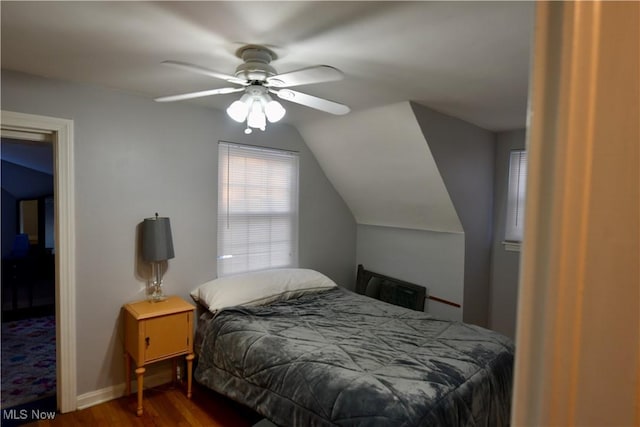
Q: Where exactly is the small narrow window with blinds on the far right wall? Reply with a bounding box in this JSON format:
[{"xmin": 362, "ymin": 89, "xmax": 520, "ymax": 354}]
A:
[{"xmin": 504, "ymin": 150, "xmax": 527, "ymax": 250}]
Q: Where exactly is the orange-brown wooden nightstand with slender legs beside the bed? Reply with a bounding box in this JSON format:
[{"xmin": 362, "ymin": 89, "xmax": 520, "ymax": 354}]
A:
[{"xmin": 124, "ymin": 296, "xmax": 195, "ymax": 416}]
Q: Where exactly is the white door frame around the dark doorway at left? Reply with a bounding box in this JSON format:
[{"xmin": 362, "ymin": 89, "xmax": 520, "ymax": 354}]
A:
[{"xmin": 1, "ymin": 110, "xmax": 77, "ymax": 412}]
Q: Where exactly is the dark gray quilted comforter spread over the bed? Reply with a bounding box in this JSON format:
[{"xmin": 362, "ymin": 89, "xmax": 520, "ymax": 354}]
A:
[{"xmin": 195, "ymin": 288, "xmax": 514, "ymax": 426}]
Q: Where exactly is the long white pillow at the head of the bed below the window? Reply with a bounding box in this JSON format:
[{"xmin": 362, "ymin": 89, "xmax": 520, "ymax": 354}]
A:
[{"xmin": 191, "ymin": 268, "xmax": 337, "ymax": 313}]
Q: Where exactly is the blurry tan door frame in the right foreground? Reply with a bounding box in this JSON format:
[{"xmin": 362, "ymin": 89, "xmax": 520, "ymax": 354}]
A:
[{"xmin": 511, "ymin": 0, "xmax": 640, "ymax": 426}]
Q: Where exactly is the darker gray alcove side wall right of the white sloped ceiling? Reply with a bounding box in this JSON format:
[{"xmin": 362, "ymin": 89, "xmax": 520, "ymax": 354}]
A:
[{"xmin": 411, "ymin": 103, "xmax": 495, "ymax": 326}]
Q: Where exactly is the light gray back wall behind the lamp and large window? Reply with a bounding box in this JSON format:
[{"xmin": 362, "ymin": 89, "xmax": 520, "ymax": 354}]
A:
[{"xmin": 1, "ymin": 70, "xmax": 356, "ymax": 394}]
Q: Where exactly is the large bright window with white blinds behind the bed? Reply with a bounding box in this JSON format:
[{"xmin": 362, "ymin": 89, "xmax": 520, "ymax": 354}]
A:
[{"xmin": 218, "ymin": 142, "xmax": 298, "ymax": 277}]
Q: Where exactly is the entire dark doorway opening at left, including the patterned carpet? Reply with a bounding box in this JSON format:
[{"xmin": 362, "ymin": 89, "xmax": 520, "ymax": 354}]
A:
[{"xmin": 0, "ymin": 134, "xmax": 56, "ymax": 410}]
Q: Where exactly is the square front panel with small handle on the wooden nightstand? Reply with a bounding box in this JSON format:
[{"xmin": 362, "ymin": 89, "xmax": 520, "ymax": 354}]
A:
[{"xmin": 146, "ymin": 312, "xmax": 192, "ymax": 363}]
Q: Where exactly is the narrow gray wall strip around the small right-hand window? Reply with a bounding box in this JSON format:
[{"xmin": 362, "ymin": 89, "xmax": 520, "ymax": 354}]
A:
[{"xmin": 489, "ymin": 129, "xmax": 526, "ymax": 338}]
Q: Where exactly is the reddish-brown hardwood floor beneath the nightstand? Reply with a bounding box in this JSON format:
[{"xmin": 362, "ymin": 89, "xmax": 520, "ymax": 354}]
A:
[{"xmin": 27, "ymin": 382, "xmax": 262, "ymax": 427}]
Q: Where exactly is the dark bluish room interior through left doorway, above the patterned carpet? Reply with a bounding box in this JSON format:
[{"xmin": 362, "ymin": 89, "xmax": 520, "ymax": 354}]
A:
[{"xmin": 0, "ymin": 135, "xmax": 55, "ymax": 323}]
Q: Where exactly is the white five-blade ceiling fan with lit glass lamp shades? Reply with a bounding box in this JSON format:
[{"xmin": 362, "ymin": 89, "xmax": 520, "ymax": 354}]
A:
[{"xmin": 155, "ymin": 45, "xmax": 351, "ymax": 133}]
